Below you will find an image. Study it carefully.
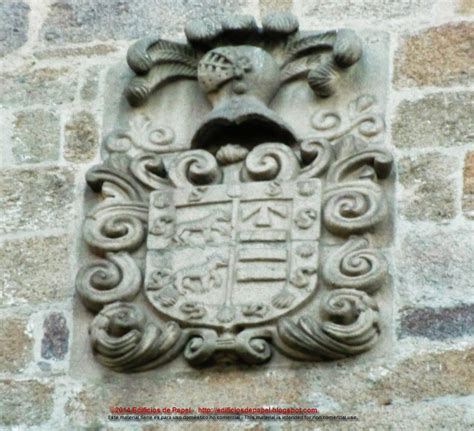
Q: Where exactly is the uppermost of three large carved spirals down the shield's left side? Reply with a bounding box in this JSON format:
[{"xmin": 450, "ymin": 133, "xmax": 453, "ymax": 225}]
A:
[{"xmin": 83, "ymin": 202, "xmax": 148, "ymax": 251}]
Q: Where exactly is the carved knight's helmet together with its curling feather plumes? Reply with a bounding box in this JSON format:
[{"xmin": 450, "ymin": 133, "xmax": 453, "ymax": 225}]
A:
[{"xmin": 126, "ymin": 13, "xmax": 362, "ymax": 152}]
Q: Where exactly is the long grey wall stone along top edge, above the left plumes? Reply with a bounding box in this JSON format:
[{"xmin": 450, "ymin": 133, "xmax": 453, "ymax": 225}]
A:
[{"xmin": 41, "ymin": 0, "xmax": 252, "ymax": 43}]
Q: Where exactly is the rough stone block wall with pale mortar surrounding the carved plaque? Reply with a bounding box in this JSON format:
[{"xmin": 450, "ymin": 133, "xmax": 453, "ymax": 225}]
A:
[{"xmin": 0, "ymin": 0, "xmax": 474, "ymax": 430}]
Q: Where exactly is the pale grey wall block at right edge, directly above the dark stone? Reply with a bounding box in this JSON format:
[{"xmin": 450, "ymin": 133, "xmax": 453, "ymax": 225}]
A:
[{"xmin": 396, "ymin": 228, "xmax": 474, "ymax": 308}]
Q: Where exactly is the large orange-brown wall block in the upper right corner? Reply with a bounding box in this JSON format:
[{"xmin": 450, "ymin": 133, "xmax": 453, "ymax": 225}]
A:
[{"xmin": 394, "ymin": 22, "xmax": 474, "ymax": 87}]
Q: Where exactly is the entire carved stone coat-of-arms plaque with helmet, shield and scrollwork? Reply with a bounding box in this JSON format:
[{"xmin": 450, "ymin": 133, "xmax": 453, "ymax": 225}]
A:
[{"xmin": 76, "ymin": 13, "xmax": 392, "ymax": 371}]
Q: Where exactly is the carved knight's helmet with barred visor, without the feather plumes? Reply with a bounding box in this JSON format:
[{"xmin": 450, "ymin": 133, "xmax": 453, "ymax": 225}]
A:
[{"xmin": 192, "ymin": 45, "xmax": 296, "ymax": 147}]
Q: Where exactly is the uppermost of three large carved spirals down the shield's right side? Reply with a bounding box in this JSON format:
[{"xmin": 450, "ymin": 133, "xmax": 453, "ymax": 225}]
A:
[{"xmin": 323, "ymin": 181, "xmax": 388, "ymax": 236}]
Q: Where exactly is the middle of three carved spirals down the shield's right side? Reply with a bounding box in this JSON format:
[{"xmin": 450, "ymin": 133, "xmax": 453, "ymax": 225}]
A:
[{"xmin": 323, "ymin": 237, "xmax": 388, "ymax": 293}]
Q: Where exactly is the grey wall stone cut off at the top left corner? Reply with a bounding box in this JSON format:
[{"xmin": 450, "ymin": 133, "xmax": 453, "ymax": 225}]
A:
[{"xmin": 0, "ymin": 1, "xmax": 30, "ymax": 57}]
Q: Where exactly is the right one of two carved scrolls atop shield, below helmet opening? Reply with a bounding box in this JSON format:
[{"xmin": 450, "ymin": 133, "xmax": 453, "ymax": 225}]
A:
[{"xmin": 241, "ymin": 143, "xmax": 300, "ymax": 181}]
